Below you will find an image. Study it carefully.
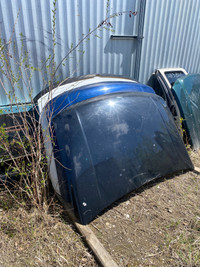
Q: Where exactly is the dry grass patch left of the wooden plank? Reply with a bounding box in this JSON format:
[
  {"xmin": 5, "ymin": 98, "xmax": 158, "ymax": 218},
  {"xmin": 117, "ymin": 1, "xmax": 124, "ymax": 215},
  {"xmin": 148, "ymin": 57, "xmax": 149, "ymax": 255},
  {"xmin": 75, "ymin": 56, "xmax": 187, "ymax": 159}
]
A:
[{"xmin": 0, "ymin": 194, "xmax": 97, "ymax": 267}]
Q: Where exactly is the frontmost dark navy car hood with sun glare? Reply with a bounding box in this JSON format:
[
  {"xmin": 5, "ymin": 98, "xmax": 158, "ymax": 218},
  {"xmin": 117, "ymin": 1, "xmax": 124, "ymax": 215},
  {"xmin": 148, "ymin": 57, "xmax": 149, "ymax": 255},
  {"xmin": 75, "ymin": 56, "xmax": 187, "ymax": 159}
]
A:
[{"xmin": 52, "ymin": 93, "xmax": 193, "ymax": 224}]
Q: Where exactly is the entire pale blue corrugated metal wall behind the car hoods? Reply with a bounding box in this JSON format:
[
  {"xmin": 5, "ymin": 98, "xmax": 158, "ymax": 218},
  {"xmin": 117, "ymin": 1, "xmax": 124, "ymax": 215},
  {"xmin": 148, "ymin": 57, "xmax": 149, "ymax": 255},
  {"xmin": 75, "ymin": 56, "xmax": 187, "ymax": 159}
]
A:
[{"xmin": 0, "ymin": 0, "xmax": 200, "ymax": 105}]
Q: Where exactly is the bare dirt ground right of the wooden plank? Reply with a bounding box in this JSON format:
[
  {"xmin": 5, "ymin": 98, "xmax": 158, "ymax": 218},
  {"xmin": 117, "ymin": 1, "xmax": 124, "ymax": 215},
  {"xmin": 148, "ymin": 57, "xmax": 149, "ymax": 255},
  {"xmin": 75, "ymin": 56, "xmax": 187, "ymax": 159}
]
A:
[{"xmin": 90, "ymin": 152, "xmax": 200, "ymax": 266}]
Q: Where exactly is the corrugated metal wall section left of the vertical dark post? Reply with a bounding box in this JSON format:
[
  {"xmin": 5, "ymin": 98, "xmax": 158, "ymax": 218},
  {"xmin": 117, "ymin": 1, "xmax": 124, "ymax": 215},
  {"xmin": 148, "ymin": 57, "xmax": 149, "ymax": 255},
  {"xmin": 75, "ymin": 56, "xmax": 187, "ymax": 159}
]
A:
[{"xmin": 0, "ymin": 0, "xmax": 139, "ymax": 105}]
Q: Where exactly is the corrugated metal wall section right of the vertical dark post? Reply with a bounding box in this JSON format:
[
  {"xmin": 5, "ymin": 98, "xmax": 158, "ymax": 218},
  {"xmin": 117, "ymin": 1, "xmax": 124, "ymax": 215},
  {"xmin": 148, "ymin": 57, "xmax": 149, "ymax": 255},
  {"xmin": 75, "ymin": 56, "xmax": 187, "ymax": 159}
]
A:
[{"xmin": 139, "ymin": 0, "xmax": 200, "ymax": 83}]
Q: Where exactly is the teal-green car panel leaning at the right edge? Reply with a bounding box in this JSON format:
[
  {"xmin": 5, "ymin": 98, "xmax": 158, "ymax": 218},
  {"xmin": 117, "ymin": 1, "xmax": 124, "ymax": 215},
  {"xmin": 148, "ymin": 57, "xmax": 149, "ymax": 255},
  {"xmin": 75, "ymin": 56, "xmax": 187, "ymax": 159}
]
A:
[{"xmin": 173, "ymin": 74, "xmax": 200, "ymax": 149}]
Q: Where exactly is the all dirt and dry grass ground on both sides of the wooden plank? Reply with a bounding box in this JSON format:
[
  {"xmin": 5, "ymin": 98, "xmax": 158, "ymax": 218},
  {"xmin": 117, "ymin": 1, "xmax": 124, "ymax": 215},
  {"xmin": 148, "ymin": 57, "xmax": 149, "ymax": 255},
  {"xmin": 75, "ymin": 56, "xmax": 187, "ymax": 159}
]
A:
[{"xmin": 0, "ymin": 152, "xmax": 200, "ymax": 267}]
